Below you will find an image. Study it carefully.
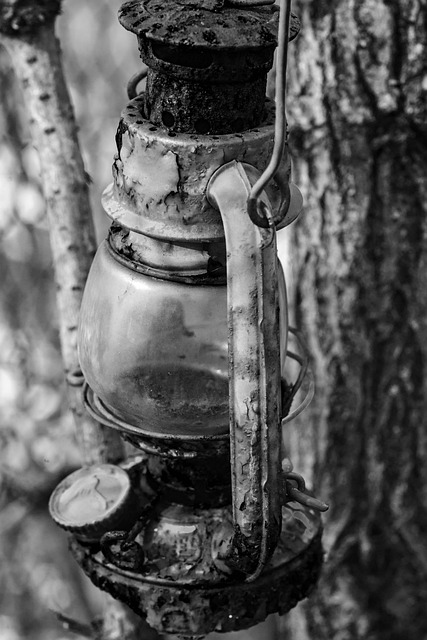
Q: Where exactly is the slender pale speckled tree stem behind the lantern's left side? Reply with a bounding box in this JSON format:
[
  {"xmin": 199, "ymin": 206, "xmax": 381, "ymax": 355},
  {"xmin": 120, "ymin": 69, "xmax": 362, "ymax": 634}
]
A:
[{"xmin": 0, "ymin": 0, "xmax": 123, "ymax": 464}]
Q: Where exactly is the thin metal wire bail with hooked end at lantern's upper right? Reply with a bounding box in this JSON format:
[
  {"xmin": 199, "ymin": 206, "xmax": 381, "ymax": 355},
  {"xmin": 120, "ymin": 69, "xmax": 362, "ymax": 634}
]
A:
[{"xmin": 248, "ymin": 0, "xmax": 291, "ymax": 229}]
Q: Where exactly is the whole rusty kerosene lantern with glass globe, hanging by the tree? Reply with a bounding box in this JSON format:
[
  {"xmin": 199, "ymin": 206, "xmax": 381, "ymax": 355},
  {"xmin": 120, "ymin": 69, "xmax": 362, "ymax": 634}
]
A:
[{"xmin": 50, "ymin": 0, "xmax": 326, "ymax": 637}]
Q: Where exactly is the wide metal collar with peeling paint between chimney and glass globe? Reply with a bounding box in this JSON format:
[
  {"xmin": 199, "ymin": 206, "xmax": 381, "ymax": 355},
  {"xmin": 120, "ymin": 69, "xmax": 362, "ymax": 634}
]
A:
[{"xmin": 103, "ymin": 95, "xmax": 290, "ymax": 242}]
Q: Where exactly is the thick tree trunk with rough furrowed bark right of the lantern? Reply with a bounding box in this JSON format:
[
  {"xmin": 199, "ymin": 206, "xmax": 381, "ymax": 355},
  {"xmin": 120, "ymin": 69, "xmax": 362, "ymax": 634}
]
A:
[{"xmin": 282, "ymin": 0, "xmax": 427, "ymax": 640}]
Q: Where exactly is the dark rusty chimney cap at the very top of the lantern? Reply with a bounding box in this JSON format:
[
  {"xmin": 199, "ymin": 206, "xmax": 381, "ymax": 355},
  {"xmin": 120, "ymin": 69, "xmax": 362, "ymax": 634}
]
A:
[{"xmin": 120, "ymin": 0, "xmax": 300, "ymax": 134}]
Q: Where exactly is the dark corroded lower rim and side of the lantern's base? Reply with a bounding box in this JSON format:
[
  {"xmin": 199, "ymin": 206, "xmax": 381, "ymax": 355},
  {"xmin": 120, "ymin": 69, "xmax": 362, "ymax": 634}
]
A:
[{"xmin": 71, "ymin": 503, "xmax": 323, "ymax": 638}]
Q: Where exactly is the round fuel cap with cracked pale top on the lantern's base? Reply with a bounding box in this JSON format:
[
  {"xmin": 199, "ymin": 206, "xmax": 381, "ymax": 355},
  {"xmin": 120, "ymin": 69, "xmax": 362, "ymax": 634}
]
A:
[{"xmin": 49, "ymin": 464, "xmax": 137, "ymax": 542}]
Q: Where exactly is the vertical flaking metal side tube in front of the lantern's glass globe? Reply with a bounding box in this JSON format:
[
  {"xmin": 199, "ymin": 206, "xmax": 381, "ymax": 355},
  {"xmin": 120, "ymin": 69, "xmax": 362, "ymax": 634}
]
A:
[{"xmin": 207, "ymin": 161, "xmax": 281, "ymax": 581}]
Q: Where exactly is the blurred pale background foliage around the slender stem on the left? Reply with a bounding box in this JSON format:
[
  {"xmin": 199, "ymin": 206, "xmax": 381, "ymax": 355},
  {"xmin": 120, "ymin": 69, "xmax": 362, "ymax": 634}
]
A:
[{"xmin": 0, "ymin": 0, "xmax": 141, "ymax": 640}]
